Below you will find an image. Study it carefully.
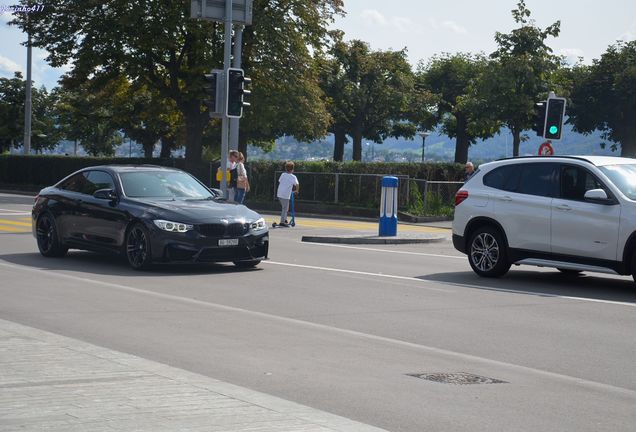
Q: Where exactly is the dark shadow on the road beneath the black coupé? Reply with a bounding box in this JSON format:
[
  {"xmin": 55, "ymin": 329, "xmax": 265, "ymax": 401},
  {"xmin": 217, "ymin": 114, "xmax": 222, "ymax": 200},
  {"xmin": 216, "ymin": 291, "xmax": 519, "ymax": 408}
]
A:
[{"xmin": 0, "ymin": 251, "xmax": 260, "ymax": 277}]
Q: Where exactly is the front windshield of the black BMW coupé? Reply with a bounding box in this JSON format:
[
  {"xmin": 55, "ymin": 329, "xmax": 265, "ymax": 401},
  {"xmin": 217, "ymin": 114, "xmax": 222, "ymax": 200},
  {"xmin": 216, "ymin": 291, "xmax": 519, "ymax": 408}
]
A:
[{"xmin": 120, "ymin": 171, "xmax": 214, "ymax": 199}]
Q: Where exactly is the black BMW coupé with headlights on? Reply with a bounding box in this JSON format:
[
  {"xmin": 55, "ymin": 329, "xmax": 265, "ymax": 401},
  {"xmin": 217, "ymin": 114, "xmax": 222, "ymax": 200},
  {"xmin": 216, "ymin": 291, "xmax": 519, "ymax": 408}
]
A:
[{"xmin": 32, "ymin": 165, "xmax": 269, "ymax": 269}]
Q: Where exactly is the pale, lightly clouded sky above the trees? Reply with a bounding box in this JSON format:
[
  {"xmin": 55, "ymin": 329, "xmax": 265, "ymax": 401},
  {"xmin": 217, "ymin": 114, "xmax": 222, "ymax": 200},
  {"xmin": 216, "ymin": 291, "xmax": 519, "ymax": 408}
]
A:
[{"xmin": 0, "ymin": 0, "xmax": 636, "ymax": 89}]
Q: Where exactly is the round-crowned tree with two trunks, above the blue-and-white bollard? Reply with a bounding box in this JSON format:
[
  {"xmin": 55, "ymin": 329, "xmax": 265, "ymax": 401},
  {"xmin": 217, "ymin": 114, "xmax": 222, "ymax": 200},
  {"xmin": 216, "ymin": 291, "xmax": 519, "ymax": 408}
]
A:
[{"xmin": 318, "ymin": 32, "xmax": 415, "ymax": 161}]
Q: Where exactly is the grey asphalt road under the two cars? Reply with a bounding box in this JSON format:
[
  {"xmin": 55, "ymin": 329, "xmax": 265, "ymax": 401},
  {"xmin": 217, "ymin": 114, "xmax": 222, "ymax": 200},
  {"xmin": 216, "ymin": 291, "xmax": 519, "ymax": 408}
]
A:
[{"xmin": 0, "ymin": 195, "xmax": 636, "ymax": 432}]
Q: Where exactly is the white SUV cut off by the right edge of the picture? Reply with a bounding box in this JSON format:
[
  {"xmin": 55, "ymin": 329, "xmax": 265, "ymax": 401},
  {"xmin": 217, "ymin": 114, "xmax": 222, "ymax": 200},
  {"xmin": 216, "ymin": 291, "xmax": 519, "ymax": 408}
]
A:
[{"xmin": 453, "ymin": 156, "xmax": 636, "ymax": 280}]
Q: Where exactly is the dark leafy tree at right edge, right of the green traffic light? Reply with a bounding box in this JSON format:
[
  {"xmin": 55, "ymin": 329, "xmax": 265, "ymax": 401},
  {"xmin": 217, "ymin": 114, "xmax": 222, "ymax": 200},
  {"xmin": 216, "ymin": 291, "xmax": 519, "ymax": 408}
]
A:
[{"xmin": 568, "ymin": 41, "xmax": 636, "ymax": 157}]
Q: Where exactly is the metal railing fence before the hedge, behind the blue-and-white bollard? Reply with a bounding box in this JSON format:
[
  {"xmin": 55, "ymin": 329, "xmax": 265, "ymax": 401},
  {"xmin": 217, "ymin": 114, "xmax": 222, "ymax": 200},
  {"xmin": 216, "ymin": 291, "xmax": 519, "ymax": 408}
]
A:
[{"xmin": 272, "ymin": 171, "xmax": 463, "ymax": 215}]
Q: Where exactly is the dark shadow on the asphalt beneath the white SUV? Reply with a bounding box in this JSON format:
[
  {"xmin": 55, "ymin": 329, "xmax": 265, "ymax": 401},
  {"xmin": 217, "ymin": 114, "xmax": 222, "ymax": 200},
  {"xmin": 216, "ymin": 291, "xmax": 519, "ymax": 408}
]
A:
[{"xmin": 418, "ymin": 269, "xmax": 636, "ymax": 304}]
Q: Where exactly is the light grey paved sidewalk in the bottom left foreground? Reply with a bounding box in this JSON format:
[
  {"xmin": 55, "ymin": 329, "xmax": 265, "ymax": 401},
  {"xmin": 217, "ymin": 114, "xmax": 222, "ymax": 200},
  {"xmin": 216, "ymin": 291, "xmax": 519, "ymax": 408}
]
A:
[{"xmin": 0, "ymin": 320, "xmax": 388, "ymax": 432}]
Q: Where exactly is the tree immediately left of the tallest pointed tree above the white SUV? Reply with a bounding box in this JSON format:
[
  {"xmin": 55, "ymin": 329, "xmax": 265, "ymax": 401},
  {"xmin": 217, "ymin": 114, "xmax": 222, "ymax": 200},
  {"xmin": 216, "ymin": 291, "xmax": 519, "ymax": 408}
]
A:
[{"xmin": 417, "ymin": 53, "xmax": 497, "ymax": 163}]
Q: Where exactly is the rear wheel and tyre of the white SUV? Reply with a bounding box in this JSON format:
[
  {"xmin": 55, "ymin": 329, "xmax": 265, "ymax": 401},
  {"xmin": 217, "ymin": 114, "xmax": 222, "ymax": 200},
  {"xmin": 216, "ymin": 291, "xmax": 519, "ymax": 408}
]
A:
[{"xmin": 468, "ymin": 226, "xmax": 511, "ymax": 277}]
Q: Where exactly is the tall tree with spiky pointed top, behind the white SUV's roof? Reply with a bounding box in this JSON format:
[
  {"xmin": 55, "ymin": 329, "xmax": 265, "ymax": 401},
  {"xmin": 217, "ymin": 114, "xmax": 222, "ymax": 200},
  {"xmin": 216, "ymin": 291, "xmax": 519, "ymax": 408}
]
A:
[{"xmin": 476, "ymin": 0, "xmax": 561, "ymax": 156}]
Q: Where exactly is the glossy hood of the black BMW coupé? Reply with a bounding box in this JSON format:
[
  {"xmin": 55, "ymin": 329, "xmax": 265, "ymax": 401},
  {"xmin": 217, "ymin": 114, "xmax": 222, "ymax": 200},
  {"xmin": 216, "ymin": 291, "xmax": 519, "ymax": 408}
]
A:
[{"xmin": 134, "ymin": 199, "xmax": 260, "ymax": 224}]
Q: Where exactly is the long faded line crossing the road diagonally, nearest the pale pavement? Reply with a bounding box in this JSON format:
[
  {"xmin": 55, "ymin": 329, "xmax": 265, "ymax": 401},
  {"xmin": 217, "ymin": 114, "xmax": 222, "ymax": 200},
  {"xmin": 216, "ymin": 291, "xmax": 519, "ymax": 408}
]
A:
[{"xmin": 0, "ymin": 261, "xmax": 636, "ymax": 397}]
